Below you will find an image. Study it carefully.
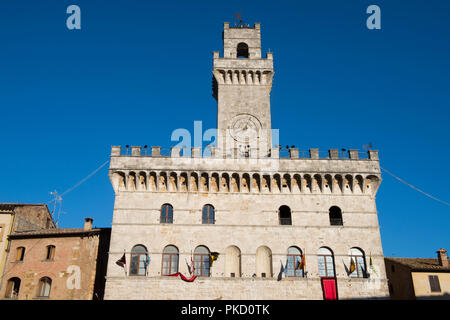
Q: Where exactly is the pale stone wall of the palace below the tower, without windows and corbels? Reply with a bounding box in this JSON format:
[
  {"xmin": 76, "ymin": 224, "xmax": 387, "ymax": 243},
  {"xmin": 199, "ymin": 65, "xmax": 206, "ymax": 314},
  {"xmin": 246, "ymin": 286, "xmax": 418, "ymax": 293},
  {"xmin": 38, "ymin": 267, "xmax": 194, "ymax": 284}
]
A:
[{"xmin": 106, "ymin": 157, "xmax": 388, "ymax": 299}]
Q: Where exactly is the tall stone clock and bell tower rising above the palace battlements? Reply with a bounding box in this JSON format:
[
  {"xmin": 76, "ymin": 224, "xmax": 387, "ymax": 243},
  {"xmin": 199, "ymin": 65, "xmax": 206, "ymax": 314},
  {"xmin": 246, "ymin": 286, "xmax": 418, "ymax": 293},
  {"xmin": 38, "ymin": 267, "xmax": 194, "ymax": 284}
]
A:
[{"xmin": 213, "ymin": 22, "xmax": 274, "ymax": 157}]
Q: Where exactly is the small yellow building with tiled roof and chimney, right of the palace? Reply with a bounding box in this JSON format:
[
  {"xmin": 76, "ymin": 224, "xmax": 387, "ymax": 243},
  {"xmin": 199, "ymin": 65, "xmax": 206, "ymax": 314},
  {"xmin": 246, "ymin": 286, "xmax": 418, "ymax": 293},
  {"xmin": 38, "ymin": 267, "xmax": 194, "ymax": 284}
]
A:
[{"xmin": 385, "ymin": 249, "xmax": 450, "ymax": 300}]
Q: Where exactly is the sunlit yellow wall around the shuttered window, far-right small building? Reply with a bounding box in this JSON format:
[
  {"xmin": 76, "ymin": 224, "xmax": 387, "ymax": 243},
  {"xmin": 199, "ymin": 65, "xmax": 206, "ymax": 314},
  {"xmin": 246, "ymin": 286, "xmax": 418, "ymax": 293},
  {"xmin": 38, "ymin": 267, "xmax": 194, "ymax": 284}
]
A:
[{"xmin": 411, "ymin": 272, "xmax": 450, "ymax": 299}]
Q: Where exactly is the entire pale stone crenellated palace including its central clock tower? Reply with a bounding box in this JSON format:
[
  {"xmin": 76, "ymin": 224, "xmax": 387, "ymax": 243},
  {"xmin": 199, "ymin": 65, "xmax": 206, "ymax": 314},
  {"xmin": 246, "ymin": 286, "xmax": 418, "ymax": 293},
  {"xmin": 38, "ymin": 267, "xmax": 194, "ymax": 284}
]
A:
[{"xmin": 105, "ymin": 23, "xmax": 389, "ymax": 300}]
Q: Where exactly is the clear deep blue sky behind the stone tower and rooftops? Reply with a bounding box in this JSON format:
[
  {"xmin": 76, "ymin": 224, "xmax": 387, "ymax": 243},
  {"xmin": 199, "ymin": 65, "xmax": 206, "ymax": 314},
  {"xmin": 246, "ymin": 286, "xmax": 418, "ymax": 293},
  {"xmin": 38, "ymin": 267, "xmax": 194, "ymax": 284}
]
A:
[{"xmin": 0, "ymin": 0, "xmax": 450, "ymax": 257}]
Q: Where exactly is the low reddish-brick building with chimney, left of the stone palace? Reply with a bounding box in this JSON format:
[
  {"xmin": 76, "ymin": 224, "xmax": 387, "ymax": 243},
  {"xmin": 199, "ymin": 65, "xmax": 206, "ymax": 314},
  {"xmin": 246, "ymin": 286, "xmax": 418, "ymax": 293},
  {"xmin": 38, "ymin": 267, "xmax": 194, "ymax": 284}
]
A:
[{"xmin": 0, "ymin": 218, "xmax": 111, "ymax": 300}]
